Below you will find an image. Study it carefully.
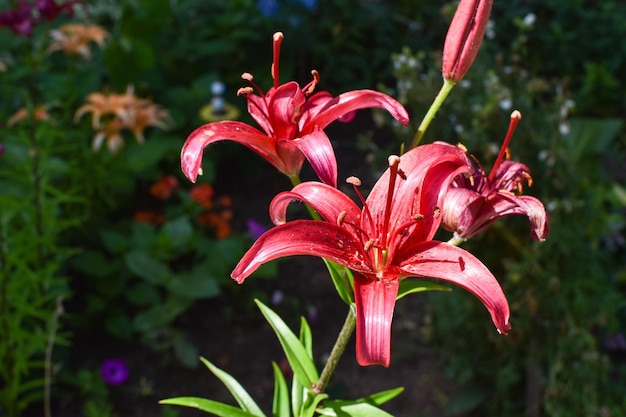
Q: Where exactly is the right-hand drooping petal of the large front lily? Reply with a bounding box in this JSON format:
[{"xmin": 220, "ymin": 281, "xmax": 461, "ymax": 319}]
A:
[{"xmin": 400, "ymin": 241, "xmax": 511, "ymax": 334}]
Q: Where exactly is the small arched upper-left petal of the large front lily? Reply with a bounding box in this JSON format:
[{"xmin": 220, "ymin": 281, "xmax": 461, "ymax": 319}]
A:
[{"xmin": 270, "ymin": 182, "xmax": 361, "ymax": 225}]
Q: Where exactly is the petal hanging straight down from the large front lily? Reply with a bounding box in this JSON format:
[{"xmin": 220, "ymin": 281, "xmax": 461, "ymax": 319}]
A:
[{"xmin": 354, "ymin": 274, "xmax": 400, "ymax": 367}]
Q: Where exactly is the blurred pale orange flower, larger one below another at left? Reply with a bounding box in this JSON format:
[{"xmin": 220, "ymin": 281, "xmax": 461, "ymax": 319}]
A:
[{"xmin": 74, "ymin": 85, "xmax": 171, "ymax": 153}]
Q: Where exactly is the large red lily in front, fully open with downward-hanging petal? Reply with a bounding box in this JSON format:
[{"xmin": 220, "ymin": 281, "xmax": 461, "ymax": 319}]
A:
[{"xmin": 231, "ymin": 144, "xmax": 510, "ymax": 366}]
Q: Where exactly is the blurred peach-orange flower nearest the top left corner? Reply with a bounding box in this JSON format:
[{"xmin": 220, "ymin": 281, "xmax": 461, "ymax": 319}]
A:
[{"xmin": 46, "ymin": 24, "xmax": 109, "ymax": 59}]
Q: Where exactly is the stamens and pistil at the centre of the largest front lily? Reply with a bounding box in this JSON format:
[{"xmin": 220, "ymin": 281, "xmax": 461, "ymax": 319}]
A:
[{"xmin": 337, "ymin": 155, "xmax": 424, "ymax": 277}]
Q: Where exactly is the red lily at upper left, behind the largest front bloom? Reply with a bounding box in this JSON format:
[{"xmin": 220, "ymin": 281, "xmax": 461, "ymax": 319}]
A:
[{"xmin": 181, "ymin": 32, "xmax": 409, "ymax": 186}]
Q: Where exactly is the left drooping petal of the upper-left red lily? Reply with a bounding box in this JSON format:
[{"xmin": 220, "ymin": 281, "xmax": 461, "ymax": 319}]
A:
[{"xmin": 180, "ymin": 121, "xmax": 290, "ymax": 182}]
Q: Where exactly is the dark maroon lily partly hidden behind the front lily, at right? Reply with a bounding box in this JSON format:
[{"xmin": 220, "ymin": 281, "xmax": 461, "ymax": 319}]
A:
[{"xmin": 442, "ymin": 111, "xmax": 549, "ymax": 242}]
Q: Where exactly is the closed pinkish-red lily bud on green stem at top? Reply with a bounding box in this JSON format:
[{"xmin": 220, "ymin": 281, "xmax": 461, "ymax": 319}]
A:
[{"xmin": 442, "ymin": 0, "xmax": 493, "ymax": 82}]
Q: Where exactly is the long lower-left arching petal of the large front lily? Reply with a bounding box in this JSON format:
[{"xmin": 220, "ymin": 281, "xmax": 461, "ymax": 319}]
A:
[{"xmin": 230, "ymin": 220, "xmax": 371, "ymax": 284}]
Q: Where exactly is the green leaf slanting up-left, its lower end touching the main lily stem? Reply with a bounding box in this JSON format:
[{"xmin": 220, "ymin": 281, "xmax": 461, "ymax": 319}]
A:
[{"xmin": 254, "ymin": 300, "xmax": 319, "ymax": 389}]
